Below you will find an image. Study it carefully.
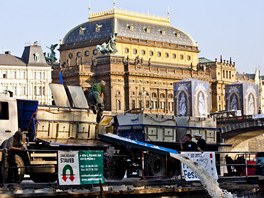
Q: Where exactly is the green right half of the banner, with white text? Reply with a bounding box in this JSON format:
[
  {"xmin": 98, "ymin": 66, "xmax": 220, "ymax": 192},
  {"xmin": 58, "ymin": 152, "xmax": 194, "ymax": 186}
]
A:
[{"xmin": 79, "ymin": 150, "xmax": 104, "ymax": 185}]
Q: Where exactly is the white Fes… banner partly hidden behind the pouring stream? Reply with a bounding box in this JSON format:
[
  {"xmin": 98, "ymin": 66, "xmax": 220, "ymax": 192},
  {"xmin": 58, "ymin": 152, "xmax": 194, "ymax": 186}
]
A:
[{"xmin": 181, "ymin": 152, "xmax": 218, "ymax": 181}]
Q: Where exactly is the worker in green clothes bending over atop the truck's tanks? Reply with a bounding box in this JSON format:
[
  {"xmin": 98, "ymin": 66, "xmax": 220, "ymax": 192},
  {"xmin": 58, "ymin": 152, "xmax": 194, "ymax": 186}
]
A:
[{"xmin": 88, "ymin": 80, "xmax": 106, "ymax": 123}]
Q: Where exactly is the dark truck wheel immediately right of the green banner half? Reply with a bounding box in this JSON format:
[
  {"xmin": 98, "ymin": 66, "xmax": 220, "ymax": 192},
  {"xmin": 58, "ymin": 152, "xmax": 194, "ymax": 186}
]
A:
[{"xmin": 104, "ymin": 156, "xmax": 126, "ymax": 180}]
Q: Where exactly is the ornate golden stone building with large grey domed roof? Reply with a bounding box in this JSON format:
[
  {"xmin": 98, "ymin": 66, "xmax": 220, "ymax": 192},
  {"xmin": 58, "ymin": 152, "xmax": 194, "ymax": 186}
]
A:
[{"xmin": 53, "ymin": 9, "xmax": 211, "ymax": 114}]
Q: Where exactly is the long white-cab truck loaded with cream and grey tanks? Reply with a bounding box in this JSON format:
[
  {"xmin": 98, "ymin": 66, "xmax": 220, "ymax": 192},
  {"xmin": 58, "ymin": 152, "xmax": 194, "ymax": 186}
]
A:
[{"xmin": 0, "ymin": 84, "xmax": 218, "ymax": 182}]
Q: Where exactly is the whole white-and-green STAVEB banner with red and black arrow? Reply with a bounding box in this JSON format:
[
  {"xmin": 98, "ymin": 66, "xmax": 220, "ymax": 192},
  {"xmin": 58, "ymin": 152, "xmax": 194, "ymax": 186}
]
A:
[{"xmin": 58, "ymin": 150, "xmax": 104, "ymax": 185}]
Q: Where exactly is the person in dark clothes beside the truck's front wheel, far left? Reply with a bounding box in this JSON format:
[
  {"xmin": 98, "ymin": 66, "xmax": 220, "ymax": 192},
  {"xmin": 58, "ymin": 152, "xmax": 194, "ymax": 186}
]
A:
[{"xmin": 1, "ymin": 131, "xmax": 25, "ymax": 183}]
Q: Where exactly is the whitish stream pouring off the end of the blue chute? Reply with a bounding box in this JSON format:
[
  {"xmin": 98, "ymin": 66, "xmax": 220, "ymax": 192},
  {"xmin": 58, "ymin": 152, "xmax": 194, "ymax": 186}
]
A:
[{"xmin": 170, "ymin": 154, "xmax": 234, "ymax": 198}]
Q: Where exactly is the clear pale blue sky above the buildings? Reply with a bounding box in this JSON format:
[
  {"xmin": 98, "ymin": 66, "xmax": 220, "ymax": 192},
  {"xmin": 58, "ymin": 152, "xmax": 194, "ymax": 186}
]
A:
[{"xmin": 0, "ymin": 0, "xmax": 264, "ymax": 75}]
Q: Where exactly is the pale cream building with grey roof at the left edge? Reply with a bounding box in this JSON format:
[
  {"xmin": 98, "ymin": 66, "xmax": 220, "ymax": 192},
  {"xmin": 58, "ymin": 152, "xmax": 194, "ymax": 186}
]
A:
[{"xmin": 0, "ymin": 42, "xmax": 52, "ymax": 105}]
